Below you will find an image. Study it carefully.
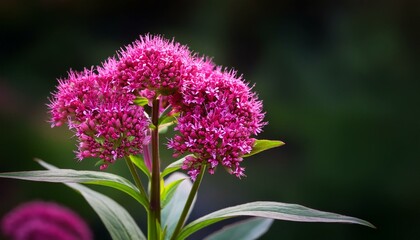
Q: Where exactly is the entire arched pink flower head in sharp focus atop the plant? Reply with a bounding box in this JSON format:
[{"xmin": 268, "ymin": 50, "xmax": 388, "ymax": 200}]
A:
[{"xmin": 49, "ymin": 35, "xmax": 265, "ymax": 179}]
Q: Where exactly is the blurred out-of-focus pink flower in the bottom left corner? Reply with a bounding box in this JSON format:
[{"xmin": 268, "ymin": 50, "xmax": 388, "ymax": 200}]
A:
[{"xmin": 1, "ymin": 201, "xmax": 92, "ymax": 240}]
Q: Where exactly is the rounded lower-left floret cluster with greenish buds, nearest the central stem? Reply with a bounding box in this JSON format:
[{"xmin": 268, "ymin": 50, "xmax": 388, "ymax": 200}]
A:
[{"xmin": 76, "ymin": 102, "xmax": 149, "ymax": 169}]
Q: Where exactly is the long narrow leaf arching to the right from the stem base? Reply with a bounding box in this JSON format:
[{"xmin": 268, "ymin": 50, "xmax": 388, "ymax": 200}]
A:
[{"xmin": 177, "ymin": 202, "xmax": 374, "ymax": 240}]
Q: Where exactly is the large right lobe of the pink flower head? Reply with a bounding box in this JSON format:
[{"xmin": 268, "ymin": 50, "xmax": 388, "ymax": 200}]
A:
[{"xmin": 168, "ymin": 68, "xmax": 265, "ymax": 179}]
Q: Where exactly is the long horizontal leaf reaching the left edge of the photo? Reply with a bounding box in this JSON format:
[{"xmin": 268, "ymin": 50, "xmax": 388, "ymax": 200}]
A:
[{"xmin": 0, "ymin": 160, "xmax": 149, "ymax": 210}]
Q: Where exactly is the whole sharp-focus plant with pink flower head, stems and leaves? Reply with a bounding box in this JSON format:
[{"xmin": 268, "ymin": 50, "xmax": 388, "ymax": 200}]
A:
[{"xmin": 0, "ymin": 35, "xmax": 373, "ymax": 240}]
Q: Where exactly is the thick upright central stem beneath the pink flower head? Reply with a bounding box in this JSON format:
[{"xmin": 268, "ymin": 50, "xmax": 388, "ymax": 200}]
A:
[{"xmin": 148, "ymin": 99, "xmax": 161, "ymax": 240}]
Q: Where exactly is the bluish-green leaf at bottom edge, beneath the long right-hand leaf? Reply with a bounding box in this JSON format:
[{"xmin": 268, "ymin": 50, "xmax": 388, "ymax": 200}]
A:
[{"xmin": 204, "ymin": 217, "xmax": 274, "ymax": 240}]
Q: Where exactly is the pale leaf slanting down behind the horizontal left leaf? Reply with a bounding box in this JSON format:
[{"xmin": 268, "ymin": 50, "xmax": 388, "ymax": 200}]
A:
[{"xmin": 38, "ymin": 160, "xmax": 146, "ymax": 240}]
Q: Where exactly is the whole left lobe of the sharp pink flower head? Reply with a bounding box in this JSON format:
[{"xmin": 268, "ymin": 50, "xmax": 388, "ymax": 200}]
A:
[{"xmin": 49, "ymin": 66, "xmax": 148, "ymax": 169}]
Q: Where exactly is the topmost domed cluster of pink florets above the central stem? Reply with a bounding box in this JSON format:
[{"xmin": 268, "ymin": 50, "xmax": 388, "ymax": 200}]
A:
[{"xmin": 117, "ymin": 35, "xmax": 191, "ymax": 95}]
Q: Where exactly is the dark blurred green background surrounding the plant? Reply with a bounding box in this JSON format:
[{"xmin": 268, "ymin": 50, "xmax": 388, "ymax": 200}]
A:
[{"xmin": 0, "ymin": 0, "xmax": 420, "ymax": 239}]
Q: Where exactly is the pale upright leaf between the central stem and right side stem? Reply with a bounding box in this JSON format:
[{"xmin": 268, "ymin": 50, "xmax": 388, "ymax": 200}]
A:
[{"xmin": 162, "ymin": 172, "xmax": 195, "ymax": 239}]
